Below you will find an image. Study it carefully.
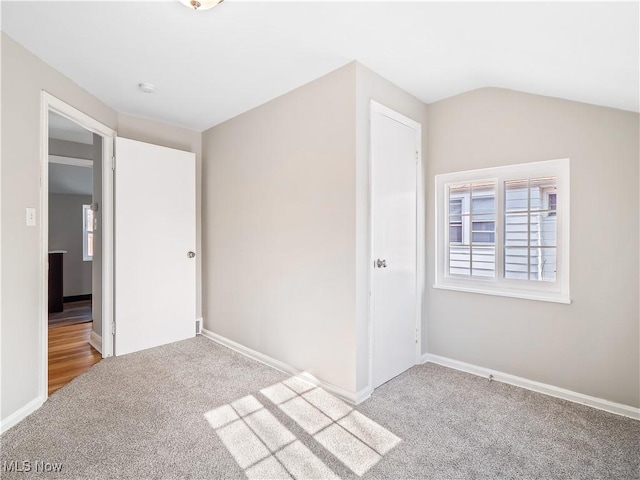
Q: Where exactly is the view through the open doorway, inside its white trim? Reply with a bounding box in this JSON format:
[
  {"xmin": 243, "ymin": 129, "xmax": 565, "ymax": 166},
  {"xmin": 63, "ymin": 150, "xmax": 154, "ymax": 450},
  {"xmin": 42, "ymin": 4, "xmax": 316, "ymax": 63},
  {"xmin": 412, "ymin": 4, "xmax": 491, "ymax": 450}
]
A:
[{"xmin": 47, "ymin": 111, "xmax": 102, "ymax": 395}]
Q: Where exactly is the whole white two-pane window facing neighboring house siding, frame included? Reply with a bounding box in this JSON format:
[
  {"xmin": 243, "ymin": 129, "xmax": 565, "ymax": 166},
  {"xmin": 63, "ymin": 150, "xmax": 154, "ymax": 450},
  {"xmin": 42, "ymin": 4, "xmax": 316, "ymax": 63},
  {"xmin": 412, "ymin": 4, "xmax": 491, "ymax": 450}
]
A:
[{"xmin": 434, "ymin": 159, "xmax": 570, "ymax": 303}]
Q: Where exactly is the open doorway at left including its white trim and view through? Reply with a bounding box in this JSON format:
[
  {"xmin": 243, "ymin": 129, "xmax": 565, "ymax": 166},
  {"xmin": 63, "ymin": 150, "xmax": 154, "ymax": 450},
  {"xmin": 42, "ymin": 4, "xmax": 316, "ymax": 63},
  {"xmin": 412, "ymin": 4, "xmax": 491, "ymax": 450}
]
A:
[{"xmin": 40, "ymin": 92, "xmax": 115, "ymax": 401}]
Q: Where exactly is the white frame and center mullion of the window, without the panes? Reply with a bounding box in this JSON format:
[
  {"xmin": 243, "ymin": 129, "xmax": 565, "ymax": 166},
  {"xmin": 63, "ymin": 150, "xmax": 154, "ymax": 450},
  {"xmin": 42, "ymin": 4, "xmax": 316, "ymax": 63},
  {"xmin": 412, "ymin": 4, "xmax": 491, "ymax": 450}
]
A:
[{"xmin": 433, "ymin": 158, "xmax": 571, "ymax": 304}]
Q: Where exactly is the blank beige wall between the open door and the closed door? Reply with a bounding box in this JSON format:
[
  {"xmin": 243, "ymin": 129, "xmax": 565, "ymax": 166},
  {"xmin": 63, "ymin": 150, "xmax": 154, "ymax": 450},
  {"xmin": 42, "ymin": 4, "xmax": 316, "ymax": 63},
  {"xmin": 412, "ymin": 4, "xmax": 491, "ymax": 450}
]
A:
[{"xmin": 202, "ymin": 63, "xmax": 356, "ymax": 392}]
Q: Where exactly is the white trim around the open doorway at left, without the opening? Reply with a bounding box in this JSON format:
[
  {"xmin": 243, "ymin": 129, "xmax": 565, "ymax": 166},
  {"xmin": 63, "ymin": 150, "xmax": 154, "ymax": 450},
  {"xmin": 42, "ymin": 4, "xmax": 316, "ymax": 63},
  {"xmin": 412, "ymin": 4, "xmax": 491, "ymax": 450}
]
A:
[{"xmin": 39, "ymin": 90, "xmax": 116, "ymax": 402}]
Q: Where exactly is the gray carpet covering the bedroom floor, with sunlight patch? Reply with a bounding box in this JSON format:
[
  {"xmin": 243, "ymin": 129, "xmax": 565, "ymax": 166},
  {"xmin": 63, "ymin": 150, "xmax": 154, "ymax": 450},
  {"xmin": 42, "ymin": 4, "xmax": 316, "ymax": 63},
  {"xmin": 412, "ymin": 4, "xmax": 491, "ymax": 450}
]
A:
[{"xmin": 0, "ymin": 337, "xmax": 640, "ymax": 480}]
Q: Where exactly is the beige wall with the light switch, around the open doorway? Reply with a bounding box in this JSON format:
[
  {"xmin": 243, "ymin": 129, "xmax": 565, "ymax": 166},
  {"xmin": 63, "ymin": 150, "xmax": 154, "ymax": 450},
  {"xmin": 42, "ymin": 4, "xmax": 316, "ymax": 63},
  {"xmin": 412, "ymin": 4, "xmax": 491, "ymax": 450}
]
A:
[{"xmin": 0, "ymin": 33, "xmax": 117, "ymax": 419}]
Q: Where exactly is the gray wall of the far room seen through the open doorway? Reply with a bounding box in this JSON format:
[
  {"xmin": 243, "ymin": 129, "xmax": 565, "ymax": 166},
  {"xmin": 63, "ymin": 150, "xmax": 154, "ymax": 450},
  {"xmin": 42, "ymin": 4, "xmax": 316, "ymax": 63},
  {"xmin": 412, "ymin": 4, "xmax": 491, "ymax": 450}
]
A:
[{"xmin": 49, "ymin": 194, "xmax": 93, "ymax": 297}]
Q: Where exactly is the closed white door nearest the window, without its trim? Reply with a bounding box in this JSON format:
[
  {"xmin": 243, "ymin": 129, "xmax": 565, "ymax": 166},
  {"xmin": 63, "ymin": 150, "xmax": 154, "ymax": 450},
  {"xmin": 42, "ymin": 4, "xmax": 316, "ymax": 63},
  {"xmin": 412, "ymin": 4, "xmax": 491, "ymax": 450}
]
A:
[{"xmin": 371, "ymin": 103, "xmax": 420, "ymax": 388}]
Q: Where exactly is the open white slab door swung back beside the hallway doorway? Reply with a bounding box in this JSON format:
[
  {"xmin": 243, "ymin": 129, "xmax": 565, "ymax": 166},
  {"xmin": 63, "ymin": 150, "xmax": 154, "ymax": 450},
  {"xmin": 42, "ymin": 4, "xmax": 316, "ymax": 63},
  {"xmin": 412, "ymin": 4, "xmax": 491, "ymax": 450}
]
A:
[{"xmin": 115, "ymin": 138, "xmax": 196, "ymax": 355}]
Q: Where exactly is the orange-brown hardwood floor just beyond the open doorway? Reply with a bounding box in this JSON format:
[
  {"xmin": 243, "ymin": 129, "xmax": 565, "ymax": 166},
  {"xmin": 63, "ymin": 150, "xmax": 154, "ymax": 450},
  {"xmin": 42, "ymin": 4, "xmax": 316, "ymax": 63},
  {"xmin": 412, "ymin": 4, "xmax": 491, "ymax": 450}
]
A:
[{"xmin": 49, "ymin": 322, "xmax": 102, "ymax": 395}]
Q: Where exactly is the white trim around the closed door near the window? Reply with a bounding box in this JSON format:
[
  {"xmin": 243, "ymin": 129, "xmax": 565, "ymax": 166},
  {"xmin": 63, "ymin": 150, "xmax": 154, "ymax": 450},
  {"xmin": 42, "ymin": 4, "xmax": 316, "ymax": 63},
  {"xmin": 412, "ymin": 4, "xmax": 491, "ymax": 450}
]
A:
[{"xmin": 368, "ymin": 100, "xmax": 426, "ymax": 392}]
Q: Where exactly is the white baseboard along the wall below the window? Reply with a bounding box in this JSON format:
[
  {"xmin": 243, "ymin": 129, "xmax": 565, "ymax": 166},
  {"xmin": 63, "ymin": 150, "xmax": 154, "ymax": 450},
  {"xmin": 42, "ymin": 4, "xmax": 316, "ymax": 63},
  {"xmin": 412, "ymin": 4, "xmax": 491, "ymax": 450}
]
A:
[{"xmin": 422, "ymin": 353, "xmax": 640, "ymax": 420}]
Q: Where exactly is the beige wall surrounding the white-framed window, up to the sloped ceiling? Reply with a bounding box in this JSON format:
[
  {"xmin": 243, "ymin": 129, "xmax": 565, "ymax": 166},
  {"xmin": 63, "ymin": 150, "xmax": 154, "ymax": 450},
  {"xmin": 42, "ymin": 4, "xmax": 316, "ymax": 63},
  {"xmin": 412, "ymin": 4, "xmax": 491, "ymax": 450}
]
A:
[{"xmin": 425, "ymin": 88, "xmax": 640, "ymax": 407}]
